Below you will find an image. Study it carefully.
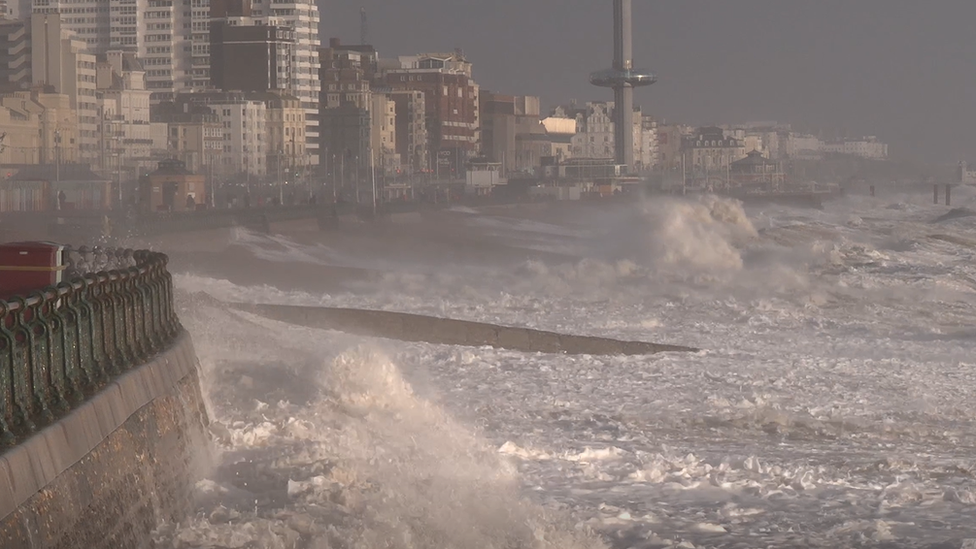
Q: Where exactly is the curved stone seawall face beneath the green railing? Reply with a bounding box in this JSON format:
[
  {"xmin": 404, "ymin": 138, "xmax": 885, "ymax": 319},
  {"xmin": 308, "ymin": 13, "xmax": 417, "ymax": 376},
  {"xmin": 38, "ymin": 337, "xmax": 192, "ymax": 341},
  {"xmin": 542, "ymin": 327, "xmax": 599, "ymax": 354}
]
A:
[{"xmin": 0, "ymin": 333, "xmax": 210, "ymax": 549}]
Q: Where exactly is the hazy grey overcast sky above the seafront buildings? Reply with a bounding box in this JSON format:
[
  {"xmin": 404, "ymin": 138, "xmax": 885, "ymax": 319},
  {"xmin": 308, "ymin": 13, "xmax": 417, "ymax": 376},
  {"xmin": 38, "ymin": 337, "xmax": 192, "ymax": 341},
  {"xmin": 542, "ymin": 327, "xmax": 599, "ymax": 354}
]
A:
[{"xmin": 319, "ymin": 0, "xmax": 976, "ymax": 162}]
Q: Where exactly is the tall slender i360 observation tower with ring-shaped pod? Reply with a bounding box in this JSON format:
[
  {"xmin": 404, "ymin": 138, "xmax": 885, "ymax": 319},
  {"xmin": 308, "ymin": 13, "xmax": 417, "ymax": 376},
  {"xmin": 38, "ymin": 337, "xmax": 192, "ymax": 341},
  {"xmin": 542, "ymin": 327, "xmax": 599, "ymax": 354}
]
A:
[{"xmin": 590, "ymin": 0, "xmax": 657, "ymax": 173}]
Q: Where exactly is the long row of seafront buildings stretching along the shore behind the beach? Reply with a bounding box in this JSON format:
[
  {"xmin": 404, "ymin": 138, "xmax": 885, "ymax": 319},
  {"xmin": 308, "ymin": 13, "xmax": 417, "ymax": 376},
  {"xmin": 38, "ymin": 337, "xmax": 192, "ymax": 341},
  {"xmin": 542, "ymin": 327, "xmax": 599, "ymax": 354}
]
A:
[{"xmin": 0, "ymin": 0, "xmax": 887, "ymax": 211}]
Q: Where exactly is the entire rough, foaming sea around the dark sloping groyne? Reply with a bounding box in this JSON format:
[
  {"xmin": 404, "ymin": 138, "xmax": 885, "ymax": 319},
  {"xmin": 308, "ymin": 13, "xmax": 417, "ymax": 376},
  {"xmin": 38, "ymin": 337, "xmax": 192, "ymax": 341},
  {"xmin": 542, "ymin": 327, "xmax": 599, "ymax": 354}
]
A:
[{"xmin": 157, "ymin": 187, "xmax": 976, "ymax": 549}]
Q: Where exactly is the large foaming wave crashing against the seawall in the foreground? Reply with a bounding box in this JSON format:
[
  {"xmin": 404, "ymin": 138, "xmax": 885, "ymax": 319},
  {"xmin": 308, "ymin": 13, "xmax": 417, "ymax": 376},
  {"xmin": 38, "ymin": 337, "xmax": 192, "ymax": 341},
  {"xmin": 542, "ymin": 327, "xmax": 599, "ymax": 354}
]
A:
[{"xmin": 156, "ymin": 295, "xmax": 602, "ymax": 549}]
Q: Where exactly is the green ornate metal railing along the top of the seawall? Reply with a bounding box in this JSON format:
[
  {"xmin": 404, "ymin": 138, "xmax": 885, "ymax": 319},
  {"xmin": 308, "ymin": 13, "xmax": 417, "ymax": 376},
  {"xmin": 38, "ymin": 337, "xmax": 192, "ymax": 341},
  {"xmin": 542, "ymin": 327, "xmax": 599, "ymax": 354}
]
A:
[{"xmin": 0, "ymin": 247, "xmax": 182, "ymax": 453}]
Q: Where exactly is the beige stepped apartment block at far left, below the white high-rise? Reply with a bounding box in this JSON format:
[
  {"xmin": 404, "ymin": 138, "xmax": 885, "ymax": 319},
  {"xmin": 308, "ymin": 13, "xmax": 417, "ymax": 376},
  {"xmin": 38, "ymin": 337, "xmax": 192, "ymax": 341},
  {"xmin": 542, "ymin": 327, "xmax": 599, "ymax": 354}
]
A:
[{"xmin": 31, "ymin": 14, "xmax": 99, "ymax": 162}]
